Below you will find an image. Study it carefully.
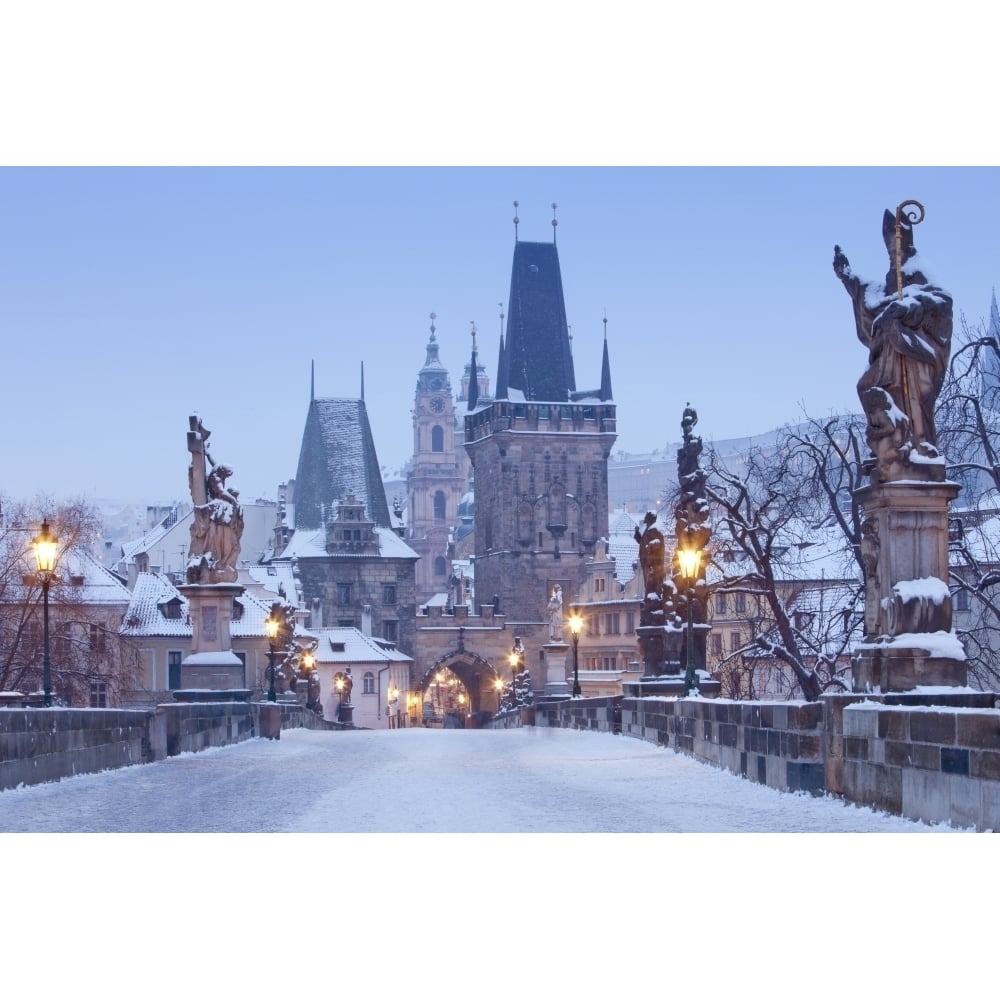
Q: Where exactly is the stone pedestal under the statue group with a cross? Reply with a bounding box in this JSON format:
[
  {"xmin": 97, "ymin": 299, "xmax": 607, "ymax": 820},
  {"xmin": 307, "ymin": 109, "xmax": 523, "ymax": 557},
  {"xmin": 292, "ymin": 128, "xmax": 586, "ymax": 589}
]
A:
[{"xmin": 178, "ymin": 583, "xmax": 246, "ymax": 691}]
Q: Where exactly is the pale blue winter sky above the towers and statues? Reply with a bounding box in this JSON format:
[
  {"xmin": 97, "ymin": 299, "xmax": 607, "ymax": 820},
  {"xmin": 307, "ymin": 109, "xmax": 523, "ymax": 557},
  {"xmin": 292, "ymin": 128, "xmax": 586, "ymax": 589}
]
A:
[{"xmin": 0, "ymin": 167, "xmax": 1000, "ymax": 502}]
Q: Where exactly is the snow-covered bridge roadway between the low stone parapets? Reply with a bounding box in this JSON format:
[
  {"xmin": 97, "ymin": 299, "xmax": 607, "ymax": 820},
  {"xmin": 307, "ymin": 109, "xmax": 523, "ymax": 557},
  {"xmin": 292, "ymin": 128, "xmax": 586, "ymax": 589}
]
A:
[{"xmin": 0, "ymin": 727, "xmax": 947, "ymax": 833}]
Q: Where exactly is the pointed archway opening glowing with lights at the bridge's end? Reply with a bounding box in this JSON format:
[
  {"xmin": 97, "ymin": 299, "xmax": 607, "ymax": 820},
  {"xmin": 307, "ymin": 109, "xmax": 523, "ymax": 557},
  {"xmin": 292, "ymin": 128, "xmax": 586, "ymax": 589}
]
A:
[{"xmin": 407, "ymin": 650, "xmax": 502, "ymax": 728}]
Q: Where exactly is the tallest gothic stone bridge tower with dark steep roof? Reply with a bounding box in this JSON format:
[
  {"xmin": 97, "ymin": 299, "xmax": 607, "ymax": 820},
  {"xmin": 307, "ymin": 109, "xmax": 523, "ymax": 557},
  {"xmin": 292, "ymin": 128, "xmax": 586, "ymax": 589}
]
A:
[{"xmin": 465, "ymin": 218, "xmax": 617, "ymax": 622}]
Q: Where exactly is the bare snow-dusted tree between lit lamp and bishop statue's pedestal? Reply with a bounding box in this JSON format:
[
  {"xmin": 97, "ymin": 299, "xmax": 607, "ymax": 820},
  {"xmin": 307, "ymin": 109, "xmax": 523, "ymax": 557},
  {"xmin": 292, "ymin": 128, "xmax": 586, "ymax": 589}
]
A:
[{"xmin": 706, "ymin": 417, "xmax": 864, "ymax": 701}]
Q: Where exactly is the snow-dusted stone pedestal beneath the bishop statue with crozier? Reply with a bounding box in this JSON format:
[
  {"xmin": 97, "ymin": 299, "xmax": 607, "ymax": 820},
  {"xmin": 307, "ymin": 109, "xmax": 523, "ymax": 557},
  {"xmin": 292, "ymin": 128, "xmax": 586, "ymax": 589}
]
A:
[{"xmin": 851, "ymin": 481, "xmax": 968, "ymax": 692}]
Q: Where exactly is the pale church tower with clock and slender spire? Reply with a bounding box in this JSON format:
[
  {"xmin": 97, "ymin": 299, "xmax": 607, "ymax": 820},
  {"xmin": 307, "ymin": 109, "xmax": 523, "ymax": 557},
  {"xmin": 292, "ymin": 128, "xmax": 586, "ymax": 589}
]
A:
[{"xmin": 406, "ymin": 313, "xmax": 468, "ymax": 607}]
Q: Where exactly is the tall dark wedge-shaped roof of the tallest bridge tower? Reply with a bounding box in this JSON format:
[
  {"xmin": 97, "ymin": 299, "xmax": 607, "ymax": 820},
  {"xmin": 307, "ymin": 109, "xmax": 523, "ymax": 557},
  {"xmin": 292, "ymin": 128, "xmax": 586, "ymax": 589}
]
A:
[{"xmin": 497, "ymin": 241, "xmax": 576, "ymax": 402}]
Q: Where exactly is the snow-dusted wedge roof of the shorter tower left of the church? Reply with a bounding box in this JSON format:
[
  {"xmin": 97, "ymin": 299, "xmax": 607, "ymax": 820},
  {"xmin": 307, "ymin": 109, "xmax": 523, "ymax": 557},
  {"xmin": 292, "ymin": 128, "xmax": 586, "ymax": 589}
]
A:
[{"xmin": 295, "ymin": 399, "xmax": 392, "ymax": 529}]
